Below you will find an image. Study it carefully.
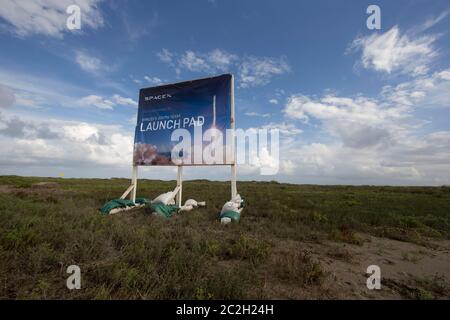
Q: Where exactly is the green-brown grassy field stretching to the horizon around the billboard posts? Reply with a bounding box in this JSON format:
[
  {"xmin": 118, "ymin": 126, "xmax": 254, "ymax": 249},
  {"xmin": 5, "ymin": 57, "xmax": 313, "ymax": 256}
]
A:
[{"xmin": 0, "ymin": 176, "xmax": 450, "ymax": 299}]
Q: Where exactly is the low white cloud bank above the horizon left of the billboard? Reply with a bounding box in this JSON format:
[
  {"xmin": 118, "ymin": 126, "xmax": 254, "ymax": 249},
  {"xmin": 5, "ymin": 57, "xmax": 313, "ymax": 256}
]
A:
[{"xmin": 0, "ymin": 113, "xmax": 133, "ymax": 168}]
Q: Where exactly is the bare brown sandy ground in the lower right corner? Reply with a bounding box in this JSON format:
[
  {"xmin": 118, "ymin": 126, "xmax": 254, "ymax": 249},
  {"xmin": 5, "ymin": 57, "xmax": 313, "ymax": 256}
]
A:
[{"xmin": 271, "ymin": 235, "xmax": 450, "ymax": 299}]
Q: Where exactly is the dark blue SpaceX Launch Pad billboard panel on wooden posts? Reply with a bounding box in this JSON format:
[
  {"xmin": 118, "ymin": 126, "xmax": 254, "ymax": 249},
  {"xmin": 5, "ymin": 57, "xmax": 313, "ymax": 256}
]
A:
[{"xmin": 133, "ymin": 74, "xmax": 233, "ymax": 166}]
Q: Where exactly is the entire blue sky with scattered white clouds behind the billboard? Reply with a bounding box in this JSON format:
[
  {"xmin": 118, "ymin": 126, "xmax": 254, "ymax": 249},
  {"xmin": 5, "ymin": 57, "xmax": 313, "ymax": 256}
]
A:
[{"xmin": 0, "ymin": 0, "xmax": 450, "ymax": 185}]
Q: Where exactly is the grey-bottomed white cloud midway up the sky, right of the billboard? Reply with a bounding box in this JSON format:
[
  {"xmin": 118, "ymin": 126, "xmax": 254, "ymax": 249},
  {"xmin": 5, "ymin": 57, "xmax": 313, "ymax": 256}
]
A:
[{"xmin": 283, "ymin": 95, "xmax": 413, "ymax": 148}]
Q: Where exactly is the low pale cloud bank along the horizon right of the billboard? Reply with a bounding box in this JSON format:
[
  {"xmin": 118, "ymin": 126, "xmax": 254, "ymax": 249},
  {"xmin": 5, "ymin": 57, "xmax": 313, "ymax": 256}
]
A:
[{"xmin": 281, "ymin": 124, "xmax": 450, "ymax": 185}]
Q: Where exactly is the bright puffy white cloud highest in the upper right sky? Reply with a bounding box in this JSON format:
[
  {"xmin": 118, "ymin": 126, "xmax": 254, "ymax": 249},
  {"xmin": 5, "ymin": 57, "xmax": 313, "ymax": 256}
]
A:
[{"xmin": 349, "ymin": 26, "xmax": 438, "ymax": 76}]
